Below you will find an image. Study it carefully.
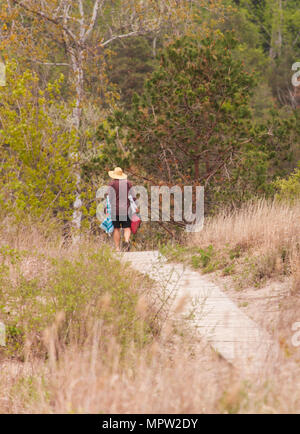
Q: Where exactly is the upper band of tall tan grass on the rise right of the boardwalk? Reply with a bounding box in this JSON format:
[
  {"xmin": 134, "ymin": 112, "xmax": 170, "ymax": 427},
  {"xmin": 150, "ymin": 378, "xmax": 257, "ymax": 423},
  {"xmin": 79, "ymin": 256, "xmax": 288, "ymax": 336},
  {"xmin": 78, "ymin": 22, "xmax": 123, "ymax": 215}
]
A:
[{"xmin": 188, "ymin": 199, "xmax": 300, "ymax": 292}]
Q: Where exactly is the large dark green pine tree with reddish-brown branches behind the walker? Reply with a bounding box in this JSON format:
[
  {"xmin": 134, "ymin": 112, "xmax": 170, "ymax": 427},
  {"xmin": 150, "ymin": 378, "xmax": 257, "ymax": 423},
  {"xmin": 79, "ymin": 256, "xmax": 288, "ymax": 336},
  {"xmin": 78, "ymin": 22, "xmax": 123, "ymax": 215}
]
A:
[{"xmin": 99, "ymin": 33, "xmax": 254, "ymax": 183}]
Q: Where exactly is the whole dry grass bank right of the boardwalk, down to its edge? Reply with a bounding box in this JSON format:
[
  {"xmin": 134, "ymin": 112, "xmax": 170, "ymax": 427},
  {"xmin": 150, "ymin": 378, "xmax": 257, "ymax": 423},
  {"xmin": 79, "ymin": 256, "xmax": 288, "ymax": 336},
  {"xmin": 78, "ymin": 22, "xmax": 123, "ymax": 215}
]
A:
[{"xmin": 188, "ymin": 199, "xmax": 300, "ymax": 336}]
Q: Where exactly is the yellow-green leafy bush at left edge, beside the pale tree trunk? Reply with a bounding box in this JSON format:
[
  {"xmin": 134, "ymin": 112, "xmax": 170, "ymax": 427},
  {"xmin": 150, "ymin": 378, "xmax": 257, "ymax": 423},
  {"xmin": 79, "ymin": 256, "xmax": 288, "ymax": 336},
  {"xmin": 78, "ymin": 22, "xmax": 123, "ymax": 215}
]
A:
[{"xmin": 0, "ymin": 63, "xmax": 77, "ymax": 219}]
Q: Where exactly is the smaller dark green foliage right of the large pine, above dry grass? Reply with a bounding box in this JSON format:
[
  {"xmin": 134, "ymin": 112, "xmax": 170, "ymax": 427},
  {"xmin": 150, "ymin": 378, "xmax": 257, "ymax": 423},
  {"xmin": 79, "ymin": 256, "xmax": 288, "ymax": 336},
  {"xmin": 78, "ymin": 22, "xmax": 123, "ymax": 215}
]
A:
[{"xmin": 210, "ymin": 109, "xmax": 299, "ymax": 212}]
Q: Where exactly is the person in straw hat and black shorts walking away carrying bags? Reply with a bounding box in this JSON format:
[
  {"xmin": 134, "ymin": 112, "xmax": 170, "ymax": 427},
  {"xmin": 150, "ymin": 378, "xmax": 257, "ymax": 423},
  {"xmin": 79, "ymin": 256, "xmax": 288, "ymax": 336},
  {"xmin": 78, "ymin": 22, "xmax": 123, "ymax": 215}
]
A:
[{"xmin": 108, "ymin": 167, "xmax": 138, "ymax": 252}]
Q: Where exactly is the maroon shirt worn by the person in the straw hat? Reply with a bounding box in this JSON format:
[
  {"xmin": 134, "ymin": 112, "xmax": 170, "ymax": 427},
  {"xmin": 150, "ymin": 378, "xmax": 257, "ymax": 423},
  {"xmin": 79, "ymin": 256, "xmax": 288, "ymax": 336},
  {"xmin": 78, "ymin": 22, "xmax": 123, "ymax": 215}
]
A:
[{"xmin": 108, "ymin": 179, "xmax": 136, "ymax": 217}]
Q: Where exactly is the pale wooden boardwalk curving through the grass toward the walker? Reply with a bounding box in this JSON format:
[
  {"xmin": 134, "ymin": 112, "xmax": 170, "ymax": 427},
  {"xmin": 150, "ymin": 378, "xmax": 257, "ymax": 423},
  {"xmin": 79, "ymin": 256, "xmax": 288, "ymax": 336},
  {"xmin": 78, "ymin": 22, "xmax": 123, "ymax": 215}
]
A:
[{"xmin": 122, "ymin": 251, "xmax": 279, "ymax": 374}]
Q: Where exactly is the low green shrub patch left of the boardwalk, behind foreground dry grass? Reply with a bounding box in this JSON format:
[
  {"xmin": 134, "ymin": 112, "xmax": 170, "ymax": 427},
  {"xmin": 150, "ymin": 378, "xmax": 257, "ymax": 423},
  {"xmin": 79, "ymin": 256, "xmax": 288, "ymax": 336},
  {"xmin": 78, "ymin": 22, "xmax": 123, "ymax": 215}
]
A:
[{"xmin": 0, "ymin": 247, "xmax": 152, "ymax": 358}]
